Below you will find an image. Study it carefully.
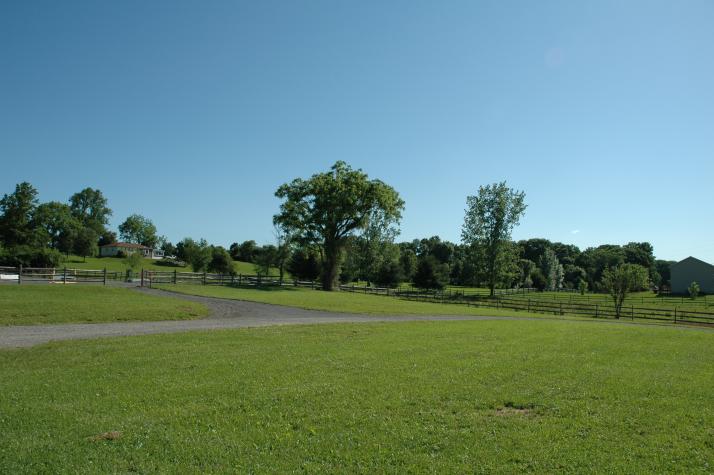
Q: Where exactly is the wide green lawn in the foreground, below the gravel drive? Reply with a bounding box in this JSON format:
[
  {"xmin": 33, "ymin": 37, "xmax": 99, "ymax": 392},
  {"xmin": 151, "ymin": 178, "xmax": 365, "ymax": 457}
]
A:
[{"xmin": 0, "ymin": 320, "xmax": 714, "ymax": 473}]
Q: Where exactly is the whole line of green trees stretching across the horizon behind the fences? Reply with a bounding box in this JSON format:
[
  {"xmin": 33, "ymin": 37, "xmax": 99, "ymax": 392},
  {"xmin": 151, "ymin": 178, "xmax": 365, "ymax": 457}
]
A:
[{"xmin": 0, "ymin": 169, "xmax": 671, "ymax": 300}]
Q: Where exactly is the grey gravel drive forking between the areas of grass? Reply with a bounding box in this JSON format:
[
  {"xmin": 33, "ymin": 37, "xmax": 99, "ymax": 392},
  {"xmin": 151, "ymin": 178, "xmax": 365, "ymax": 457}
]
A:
[{"xmin": 0, "ymin": 288, "xmax": 509, "ymax": 348}]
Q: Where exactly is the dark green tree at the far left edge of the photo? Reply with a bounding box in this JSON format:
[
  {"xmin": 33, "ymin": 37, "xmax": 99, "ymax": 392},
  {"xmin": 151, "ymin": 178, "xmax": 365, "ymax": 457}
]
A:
[{"xmin": 0, "ymin": 181, "xmax": 38, "ymax": 247}]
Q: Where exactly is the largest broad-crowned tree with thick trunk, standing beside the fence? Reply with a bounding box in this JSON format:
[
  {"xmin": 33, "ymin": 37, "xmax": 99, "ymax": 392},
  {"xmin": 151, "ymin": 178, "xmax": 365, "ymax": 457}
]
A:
[{"xmin": 273, "ymin": 161, "xmax": 404, "ymax": 290}]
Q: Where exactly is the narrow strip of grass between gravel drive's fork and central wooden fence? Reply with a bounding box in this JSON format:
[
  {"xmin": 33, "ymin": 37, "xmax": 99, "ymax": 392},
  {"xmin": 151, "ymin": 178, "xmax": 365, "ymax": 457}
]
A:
[{"xmin": 154, "ymin": 284, "xmax": 537, "ymax": 317}]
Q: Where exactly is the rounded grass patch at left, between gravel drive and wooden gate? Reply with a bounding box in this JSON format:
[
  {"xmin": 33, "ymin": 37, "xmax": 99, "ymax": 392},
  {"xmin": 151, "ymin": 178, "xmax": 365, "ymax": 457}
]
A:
[{"xmin": 0, "ymin": 284, "xmax": 208, "ymax": 325}]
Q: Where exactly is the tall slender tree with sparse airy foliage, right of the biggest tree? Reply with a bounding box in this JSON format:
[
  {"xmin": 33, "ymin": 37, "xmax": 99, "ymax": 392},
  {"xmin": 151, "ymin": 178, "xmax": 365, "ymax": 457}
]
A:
[{"xmin": 461, "ymin": 181, "xmax": 527, "ymax": 296}]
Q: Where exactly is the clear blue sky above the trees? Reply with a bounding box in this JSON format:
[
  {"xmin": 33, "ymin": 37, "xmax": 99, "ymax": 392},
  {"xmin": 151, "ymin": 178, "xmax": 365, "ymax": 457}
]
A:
[{"xmin": 0, "ymin": 0, "xmax": 714, "ymax": 262}]
